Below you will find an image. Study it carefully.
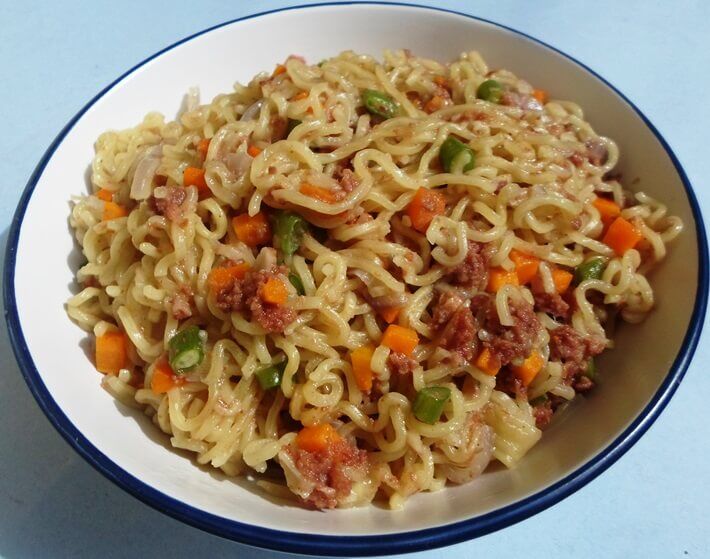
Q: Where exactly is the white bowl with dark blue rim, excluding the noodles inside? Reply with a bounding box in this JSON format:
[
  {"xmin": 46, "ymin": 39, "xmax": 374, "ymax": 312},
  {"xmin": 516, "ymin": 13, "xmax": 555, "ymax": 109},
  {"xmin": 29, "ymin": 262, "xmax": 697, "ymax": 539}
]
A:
[{"xmin": 4, "ymin": 4, "xmax": 708, "ymax": 555}]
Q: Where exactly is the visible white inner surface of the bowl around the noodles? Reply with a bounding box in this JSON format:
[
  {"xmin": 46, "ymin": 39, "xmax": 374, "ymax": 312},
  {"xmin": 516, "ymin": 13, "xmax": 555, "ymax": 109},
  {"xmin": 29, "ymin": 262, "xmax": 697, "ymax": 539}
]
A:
[{"xmin": 8, "ymin": 5, "xmax": 698, "ymax": 548}]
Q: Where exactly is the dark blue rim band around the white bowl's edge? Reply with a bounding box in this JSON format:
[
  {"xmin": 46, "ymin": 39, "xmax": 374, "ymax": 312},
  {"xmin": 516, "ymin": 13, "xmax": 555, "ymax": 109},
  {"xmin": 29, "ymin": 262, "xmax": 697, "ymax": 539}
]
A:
[{"xmin": 3, "ymin": 1, "xmax": 708, "ymax": 556}]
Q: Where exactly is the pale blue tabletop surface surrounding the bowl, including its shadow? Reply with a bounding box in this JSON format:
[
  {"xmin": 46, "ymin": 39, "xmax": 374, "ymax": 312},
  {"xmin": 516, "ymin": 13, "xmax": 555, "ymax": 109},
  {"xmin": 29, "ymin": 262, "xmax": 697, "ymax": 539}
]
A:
[{"xmin": 0, "ymin": 0, "xmax": 710, "ymax": 559}]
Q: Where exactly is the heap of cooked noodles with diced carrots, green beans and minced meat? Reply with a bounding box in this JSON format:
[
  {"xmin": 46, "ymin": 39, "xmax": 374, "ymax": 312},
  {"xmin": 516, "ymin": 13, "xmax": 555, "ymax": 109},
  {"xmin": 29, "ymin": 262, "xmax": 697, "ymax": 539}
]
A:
[{"xmin": 67, "ymin": 51, "xmax": 682, "ymax": 508}]
